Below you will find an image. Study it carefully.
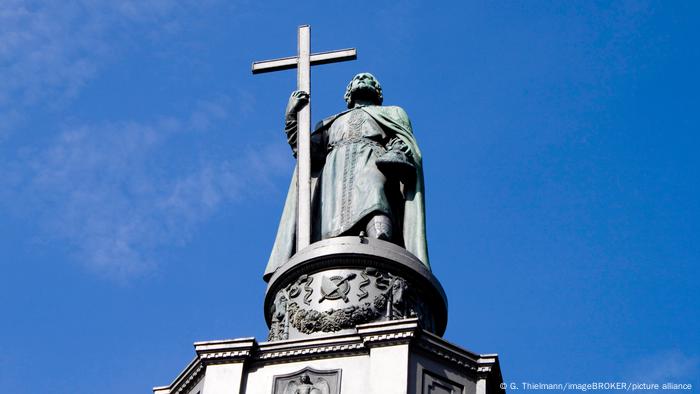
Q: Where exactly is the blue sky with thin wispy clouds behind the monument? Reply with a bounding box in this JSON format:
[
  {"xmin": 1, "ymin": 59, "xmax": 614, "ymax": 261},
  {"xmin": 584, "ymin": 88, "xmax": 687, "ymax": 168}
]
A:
[{"xmin": 0, "ymin": 0, "xmax": 700, "ymax": 394}]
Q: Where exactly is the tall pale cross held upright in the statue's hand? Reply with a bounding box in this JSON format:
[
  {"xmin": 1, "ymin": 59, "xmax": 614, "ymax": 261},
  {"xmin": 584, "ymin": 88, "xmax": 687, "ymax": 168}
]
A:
[{"xmin": 253, "ymin": 25, "xmax": 357, "ymax": 251}]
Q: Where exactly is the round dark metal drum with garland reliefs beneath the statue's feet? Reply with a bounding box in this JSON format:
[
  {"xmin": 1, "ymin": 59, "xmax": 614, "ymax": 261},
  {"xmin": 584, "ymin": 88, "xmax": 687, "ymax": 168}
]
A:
[{"xmin": 265, "ymin": 236, "xmax": 447, "ymax": 341}]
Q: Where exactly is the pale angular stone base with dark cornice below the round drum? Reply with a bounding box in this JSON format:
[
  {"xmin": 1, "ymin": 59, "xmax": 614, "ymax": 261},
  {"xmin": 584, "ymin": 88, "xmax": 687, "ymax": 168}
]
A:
[{"xmin": 153, "ymin": 318, "xmax": 505, "ymax": 394}]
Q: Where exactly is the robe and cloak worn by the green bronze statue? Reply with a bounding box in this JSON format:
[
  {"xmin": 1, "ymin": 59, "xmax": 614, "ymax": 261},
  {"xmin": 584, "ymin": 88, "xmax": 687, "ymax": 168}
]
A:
[{"xmin": 263, "ymin": 106, "xmax": 430, "ymax": 281}]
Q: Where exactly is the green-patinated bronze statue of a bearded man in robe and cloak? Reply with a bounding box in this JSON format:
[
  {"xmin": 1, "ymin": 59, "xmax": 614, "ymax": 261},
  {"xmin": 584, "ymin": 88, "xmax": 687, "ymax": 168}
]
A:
[{"xmin": 264, "ymin": 73, "xmax": 429, "ymax": 280}]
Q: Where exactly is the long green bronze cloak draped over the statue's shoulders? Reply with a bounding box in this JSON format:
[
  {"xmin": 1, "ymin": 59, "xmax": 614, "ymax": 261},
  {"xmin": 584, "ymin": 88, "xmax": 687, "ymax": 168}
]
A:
[{"xmin": 263, "ymin": 105, "xmax": 430, "ymax": 281}]
